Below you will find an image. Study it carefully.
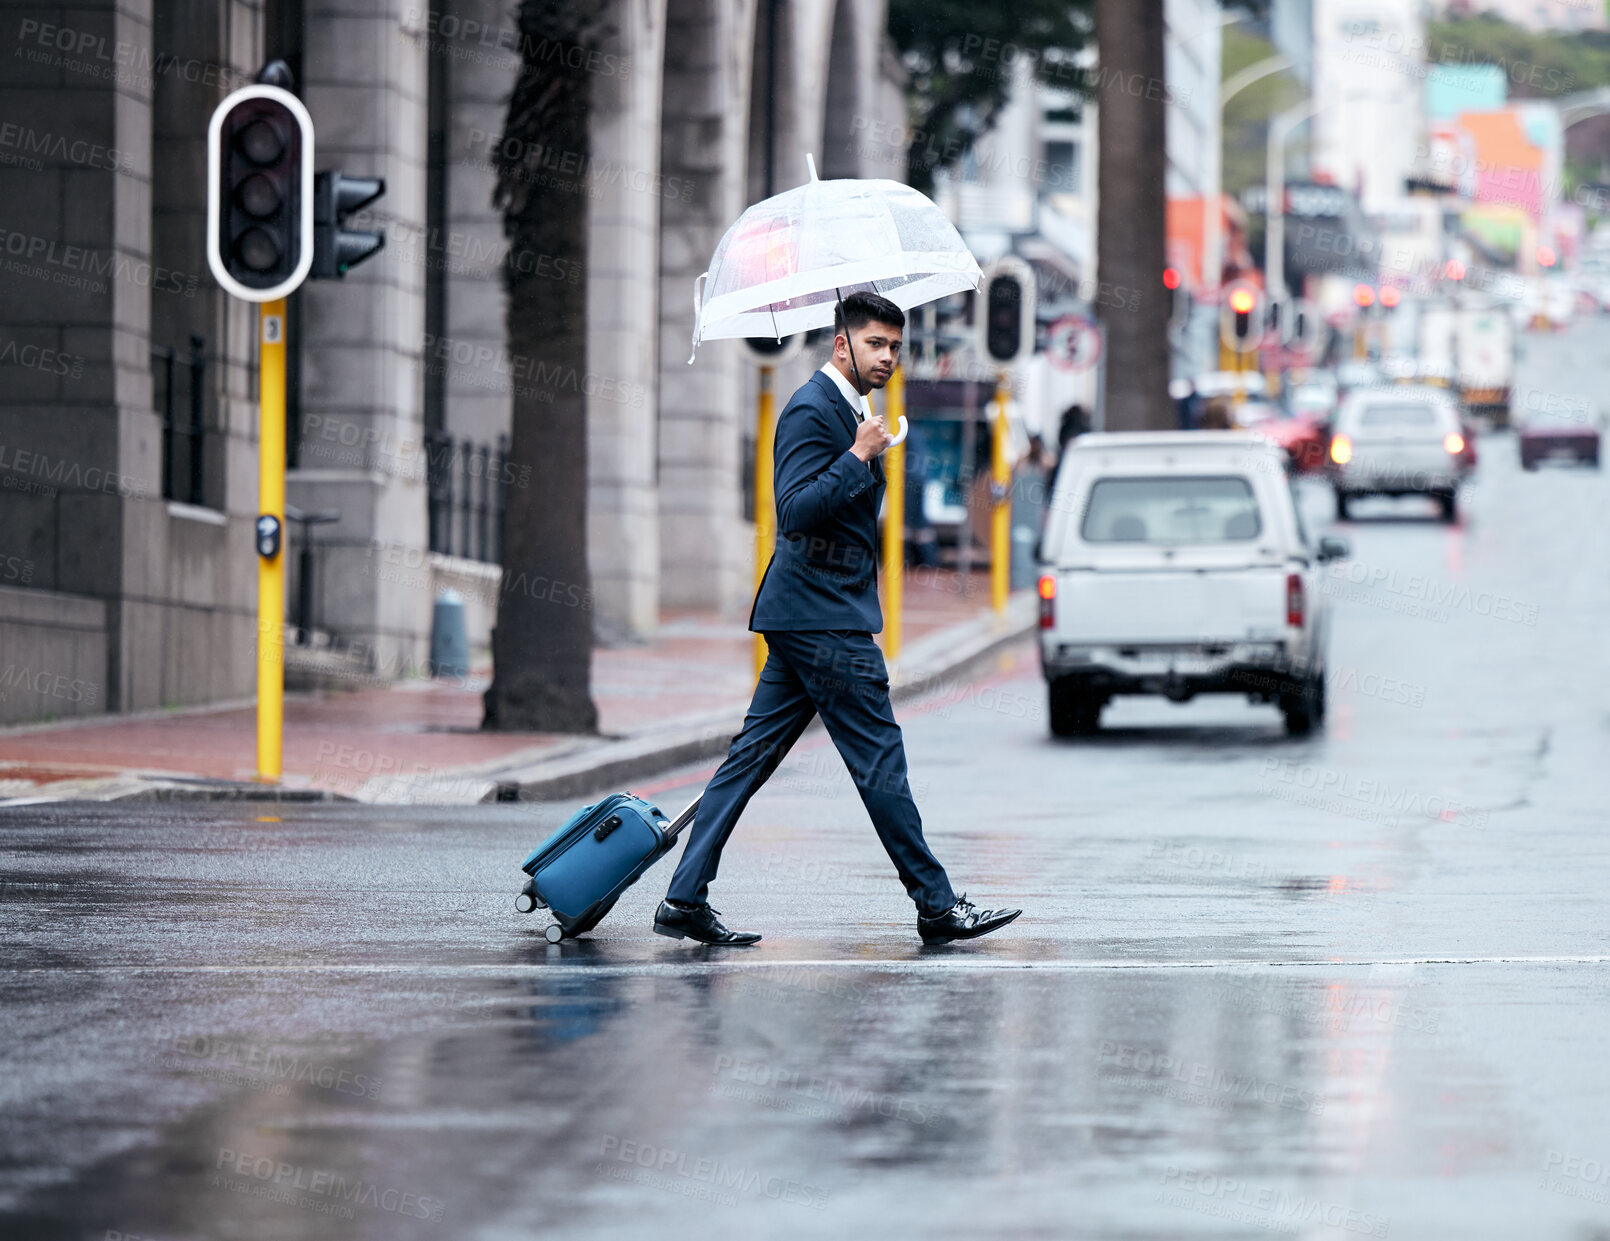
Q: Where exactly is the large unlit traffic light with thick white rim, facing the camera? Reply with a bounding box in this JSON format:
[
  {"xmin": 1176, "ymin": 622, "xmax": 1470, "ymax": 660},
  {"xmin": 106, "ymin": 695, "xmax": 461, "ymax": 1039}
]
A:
[{"xmin": 206, "ymin": 84, "xmax": 314, "ymax": 301}]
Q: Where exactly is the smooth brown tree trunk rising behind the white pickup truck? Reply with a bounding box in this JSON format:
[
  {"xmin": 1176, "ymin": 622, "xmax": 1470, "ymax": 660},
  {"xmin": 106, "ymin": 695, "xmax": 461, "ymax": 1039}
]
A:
[{"xmin": 1096, "ymin": 0, "xmax": 1179, "ymax": 431}]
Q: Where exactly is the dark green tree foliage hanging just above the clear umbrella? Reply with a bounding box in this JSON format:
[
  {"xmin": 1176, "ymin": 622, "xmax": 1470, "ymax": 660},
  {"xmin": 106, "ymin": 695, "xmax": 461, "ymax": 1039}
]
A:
[{"xmin": 889, "ymin": 0, "xmax": 1093, "ymax": 193}]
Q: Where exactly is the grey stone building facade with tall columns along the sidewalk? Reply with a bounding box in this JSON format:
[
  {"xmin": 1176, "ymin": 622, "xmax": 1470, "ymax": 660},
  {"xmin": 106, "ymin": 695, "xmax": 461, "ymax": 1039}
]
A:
[{"xmin": 0, "ymin": 0, "xmax": 903, "ymax": 723}]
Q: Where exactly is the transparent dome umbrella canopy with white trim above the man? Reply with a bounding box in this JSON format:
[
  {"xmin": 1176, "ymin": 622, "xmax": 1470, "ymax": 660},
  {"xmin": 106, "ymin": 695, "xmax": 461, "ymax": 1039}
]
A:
[{"xmin": 687, "ymin": 156, "xmax": 982, "ymax": 362}]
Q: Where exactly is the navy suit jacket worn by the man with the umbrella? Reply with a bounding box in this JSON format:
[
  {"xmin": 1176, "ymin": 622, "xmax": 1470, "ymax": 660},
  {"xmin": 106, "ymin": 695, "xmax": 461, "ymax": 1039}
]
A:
[{"xmin": 749, "ymin": 370, "xmax": 884, "ymax": 634}]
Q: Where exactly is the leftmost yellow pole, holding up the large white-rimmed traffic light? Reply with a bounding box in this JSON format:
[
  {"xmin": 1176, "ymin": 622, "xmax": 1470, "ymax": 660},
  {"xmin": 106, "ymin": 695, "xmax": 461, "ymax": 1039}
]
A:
[{"xmin": 258, "ymin": 298, "xmax": 285, "ymax": 781}]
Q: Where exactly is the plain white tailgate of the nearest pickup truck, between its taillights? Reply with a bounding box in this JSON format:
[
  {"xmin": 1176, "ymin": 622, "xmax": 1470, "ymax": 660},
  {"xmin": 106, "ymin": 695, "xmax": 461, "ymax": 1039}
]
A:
[{"xmin": 1051, "ymin": 565, "xmax": 1286, "ymax": 645}]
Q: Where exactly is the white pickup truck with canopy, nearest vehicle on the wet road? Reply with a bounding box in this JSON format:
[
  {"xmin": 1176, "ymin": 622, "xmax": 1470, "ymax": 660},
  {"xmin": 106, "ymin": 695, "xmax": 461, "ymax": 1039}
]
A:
[{"xmin": 1040, "ymin": 431, "xmax": 1349, "ymax": 737}]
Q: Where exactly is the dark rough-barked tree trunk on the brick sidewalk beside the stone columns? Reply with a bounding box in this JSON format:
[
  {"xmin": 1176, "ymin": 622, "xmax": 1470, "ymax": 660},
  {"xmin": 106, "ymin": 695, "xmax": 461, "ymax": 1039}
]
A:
[{"xmin": 483, "ymin": 0, "xmax": 601, "ymax": 732}]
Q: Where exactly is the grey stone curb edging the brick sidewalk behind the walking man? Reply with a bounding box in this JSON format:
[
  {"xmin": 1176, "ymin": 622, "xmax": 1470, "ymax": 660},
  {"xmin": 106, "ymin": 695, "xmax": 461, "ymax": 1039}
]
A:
[{"xmin": 481, "ymin": 594, "xmax": 1038, "ymax": 803}]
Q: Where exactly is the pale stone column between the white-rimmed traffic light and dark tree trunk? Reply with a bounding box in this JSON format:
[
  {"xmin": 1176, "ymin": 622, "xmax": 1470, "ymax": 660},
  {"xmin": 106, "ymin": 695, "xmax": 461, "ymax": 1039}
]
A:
[{"xmin": 287, "ymin": 0, "xmax": 431, "ymax": 676}]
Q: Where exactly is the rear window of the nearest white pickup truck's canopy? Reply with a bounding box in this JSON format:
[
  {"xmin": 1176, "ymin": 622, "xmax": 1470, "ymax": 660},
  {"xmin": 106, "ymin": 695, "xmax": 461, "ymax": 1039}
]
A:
[{"xmin": 1080, "ymin": 475, "xmax": 1264, "ymax": 542}]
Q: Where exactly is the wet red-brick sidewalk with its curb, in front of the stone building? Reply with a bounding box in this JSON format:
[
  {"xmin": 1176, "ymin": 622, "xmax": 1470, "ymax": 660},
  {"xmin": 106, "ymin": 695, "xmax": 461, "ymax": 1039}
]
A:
[{"xmin": 0, "ymin": 570, "xmax": 1035, "ymax": 805}]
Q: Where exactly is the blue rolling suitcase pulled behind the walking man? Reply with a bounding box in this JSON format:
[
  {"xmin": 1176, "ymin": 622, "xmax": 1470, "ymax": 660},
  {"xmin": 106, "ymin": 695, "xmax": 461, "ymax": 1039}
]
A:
[{"xmin": 514, "ymin": 794, "xmax": 699, "ymax": 943}]
